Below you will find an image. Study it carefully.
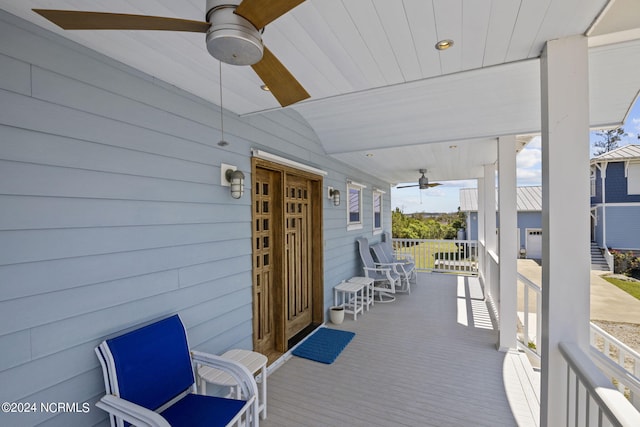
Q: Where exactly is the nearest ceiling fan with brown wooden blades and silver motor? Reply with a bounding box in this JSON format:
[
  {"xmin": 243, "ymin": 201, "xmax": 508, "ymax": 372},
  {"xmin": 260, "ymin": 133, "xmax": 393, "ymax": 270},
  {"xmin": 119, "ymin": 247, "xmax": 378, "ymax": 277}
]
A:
[{"xmin": 33, "ymin": 0, "xmax": 310, "ymax": 107}]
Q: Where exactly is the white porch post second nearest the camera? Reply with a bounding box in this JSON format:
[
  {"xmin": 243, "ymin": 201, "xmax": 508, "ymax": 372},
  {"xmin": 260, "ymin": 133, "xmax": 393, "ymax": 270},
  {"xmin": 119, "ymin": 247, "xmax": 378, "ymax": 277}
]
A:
[{"xmin": 498, "ymin": 136, "xmax": 518, "ymax": 351}]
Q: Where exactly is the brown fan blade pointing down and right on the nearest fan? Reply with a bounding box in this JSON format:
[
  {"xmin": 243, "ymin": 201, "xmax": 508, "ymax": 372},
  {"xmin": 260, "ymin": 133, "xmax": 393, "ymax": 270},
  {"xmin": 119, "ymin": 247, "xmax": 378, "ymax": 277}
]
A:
[{"xmin": 251, "ymin": 46, "xmax": 310, "ymax": 107}]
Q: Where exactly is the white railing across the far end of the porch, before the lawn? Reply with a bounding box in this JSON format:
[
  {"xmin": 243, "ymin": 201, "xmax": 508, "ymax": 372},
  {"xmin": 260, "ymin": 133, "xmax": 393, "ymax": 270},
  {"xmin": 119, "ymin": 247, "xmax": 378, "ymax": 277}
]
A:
[{"xmin": 393, "ymin": 239, "xmax": 478, "ymax": 275}]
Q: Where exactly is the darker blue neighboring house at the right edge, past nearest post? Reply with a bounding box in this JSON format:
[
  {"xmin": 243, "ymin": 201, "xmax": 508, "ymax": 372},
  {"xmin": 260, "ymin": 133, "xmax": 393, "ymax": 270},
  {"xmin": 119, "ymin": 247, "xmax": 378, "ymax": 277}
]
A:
[{"xmin": 591, "ymin": 144, "xmax": 640, "ymax": 251}]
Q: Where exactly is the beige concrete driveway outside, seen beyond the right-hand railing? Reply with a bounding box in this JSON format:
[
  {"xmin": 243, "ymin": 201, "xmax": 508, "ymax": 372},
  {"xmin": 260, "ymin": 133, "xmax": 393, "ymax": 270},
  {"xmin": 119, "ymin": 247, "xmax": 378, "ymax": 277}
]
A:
[{"xmin": 518, "ymin": 259, "xmax": 640, "ymax": 324}]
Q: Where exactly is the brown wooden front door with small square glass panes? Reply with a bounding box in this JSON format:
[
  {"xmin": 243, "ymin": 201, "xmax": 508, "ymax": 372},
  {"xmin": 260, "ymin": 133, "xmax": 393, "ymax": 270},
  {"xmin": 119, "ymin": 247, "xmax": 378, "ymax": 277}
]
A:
[{"xmin": 252, "ymin": 159, "xmax": 324, "ymax": 360}]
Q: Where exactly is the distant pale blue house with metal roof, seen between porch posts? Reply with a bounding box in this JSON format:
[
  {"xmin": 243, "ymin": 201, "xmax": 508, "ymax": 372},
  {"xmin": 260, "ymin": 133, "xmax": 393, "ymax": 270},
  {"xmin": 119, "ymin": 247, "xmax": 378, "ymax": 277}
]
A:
[{"xmin": 460, "ymin": 186, "xmax": 542, "ymax": 259}]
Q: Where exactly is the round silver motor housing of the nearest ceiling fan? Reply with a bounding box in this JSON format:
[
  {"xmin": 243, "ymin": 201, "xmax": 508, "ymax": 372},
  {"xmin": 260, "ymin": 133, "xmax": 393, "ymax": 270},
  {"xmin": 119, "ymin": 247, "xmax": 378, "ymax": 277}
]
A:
[{"xmin": 206, "ymin": 0, "xmax": 263, "ymax": 65}]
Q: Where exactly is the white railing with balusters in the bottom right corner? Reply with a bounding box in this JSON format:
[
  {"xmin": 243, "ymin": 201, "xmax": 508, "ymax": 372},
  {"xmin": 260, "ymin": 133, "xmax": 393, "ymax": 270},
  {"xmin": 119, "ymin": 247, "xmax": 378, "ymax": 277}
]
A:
[{"xmin": 560, "ymin": 342, "xmax": 640, "ymax": 427}]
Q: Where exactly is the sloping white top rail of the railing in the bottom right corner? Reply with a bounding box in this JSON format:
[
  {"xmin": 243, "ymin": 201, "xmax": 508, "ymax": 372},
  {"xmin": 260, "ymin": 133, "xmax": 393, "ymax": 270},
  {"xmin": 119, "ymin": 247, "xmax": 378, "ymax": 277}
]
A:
[{"xmin": 559, "ymin": 342, "xmax": 640, "ymax": 427}]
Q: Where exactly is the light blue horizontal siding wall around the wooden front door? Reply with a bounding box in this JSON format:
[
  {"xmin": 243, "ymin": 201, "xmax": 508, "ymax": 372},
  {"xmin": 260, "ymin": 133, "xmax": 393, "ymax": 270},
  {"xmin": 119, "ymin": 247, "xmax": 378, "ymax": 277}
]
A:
[{"xmin": 0, "ymin": 11, "xmax": 391, "ymax": 426}]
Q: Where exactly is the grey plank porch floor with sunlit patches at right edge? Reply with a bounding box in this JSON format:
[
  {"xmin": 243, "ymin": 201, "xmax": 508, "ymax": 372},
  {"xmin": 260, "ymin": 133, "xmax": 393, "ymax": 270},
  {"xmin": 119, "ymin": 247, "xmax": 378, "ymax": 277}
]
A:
[{"xmin": 261, "ymin": 274, "xmax": 539, "ymax": 427}]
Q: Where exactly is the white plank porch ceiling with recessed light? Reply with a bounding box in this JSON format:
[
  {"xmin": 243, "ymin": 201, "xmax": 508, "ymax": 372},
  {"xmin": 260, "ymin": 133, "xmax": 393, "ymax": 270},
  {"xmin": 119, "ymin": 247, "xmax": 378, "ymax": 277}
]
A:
[{"xmin": 2, "ymin": 0, "xmax": 640, "ymax": 183}]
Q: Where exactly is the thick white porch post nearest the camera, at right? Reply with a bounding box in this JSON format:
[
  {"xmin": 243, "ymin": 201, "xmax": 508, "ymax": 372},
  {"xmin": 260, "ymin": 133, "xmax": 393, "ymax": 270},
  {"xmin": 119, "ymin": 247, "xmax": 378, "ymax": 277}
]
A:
[{"xmin": 540, "ymin": 36, "xmax": 590, "ymax": 427}]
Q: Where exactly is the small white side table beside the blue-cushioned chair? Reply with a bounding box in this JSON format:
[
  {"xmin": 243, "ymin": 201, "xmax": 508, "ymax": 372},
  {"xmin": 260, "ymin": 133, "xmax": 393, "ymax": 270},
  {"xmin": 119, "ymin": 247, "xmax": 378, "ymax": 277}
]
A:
[{"xmin": 198, "ymin": 349, "xmax": 268, "ymax": 420}]
